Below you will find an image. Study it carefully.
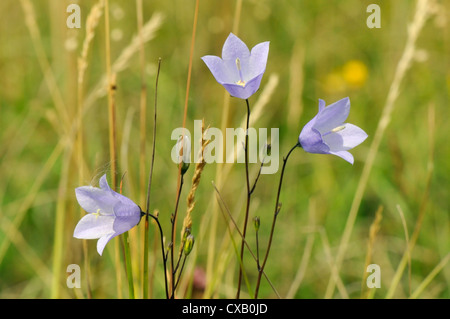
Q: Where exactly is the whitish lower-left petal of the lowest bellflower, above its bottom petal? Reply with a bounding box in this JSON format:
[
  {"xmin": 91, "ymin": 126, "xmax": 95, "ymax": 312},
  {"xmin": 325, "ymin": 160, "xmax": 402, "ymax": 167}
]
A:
[{"xmin": 73, "ymin": 214, "xmax": 115, "ymax": 239}]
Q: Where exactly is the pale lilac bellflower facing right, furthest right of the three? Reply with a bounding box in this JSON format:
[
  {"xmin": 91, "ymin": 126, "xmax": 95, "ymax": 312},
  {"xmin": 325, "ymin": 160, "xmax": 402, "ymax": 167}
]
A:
[{"xmin": 298, "ymin": 97, "xmax": 367, "ymax": 164}]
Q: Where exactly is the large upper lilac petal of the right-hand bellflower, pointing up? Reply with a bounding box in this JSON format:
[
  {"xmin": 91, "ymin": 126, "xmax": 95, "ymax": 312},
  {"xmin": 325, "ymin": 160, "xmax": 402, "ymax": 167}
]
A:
[{"xmin": 314, "ymin": 97, "xmax": 350, "ymax": 134}]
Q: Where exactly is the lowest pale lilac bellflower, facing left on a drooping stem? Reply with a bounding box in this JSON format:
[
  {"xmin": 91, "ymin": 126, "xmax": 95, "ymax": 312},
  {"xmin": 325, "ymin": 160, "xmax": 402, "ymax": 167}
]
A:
[{"xmin": 73, "ymin": 175, "xmax": 142, "ymax": 255}]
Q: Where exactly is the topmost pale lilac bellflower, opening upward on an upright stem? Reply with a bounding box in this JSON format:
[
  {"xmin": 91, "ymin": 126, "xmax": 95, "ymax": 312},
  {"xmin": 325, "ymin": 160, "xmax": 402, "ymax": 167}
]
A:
[{"xmin": 202, "ymin": 33, "xmax": 269, "ymax": 100}]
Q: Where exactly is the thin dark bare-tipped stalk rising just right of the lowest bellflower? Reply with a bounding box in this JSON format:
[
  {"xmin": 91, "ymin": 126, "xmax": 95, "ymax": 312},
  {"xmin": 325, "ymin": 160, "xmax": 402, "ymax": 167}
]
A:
[{"xmin": 142, "ymin": 58, "xmax": 161, "ymax": 299}]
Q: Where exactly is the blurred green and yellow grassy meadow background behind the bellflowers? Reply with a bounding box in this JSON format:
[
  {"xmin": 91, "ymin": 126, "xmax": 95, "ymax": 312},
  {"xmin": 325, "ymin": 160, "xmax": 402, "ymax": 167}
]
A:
[{"xmin": 0, "ymin": 0, "xmax": 450, "ymax": 298}]
